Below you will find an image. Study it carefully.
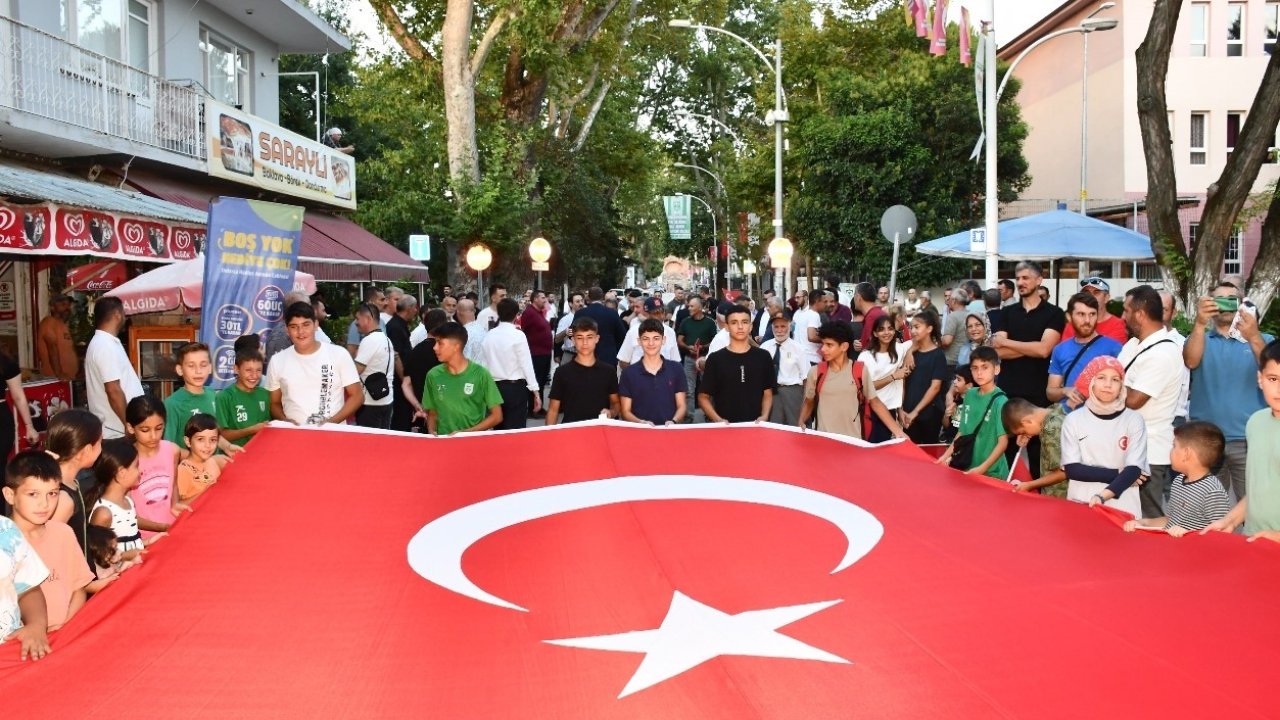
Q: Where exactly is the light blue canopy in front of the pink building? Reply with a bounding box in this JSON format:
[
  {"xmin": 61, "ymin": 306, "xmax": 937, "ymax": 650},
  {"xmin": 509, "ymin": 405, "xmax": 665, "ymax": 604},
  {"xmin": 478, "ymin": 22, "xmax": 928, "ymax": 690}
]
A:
[{"xmin": 915, "ymin": 210, "xmax": 1155, "ymax": 260}]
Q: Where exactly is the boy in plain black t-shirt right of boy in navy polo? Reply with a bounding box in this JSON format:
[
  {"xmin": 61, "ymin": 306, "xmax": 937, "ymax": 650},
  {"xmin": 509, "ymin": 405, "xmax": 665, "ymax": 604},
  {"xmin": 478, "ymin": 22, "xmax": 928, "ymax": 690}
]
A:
[{"xmin": 698, "ymin": 305, "xmax": 774, "ymax": 423}]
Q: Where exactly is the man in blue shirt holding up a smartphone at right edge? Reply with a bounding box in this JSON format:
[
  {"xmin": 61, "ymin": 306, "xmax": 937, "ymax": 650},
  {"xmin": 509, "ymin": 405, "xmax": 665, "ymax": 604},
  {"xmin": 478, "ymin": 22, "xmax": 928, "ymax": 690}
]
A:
[{"xmin": 1183, "ymin": 282, "xmax": 1272, "ymax": 501}]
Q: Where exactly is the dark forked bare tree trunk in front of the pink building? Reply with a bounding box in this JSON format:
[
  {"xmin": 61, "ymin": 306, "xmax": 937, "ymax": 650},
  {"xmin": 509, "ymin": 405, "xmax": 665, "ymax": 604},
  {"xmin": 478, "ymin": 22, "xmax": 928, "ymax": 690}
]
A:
[{"xmin": 1135, "ymin": 0, "xmax": 1280, "ymax": 313}]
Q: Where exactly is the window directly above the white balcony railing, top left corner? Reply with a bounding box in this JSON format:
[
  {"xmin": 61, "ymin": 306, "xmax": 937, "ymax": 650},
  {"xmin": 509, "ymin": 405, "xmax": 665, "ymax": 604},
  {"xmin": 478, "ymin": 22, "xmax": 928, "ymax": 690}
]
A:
[{"xmin": 60, "ymin": 0, "xmax": 155, "ymax": 72}]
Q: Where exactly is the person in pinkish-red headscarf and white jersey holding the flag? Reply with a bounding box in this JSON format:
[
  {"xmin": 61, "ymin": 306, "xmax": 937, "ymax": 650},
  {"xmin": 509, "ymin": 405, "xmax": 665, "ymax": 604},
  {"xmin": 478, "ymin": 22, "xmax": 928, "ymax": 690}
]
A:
[{"xmin": 1062, "ymin": 356, "xmax": 1148, "ymax": 518}]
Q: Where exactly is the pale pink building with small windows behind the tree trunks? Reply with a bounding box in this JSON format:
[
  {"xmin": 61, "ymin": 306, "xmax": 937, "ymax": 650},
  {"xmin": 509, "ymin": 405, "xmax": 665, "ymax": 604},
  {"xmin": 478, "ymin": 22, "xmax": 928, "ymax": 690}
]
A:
[{"xmin": 1000, "ymin": 0, "xmax": 1280, "ymax": 286}]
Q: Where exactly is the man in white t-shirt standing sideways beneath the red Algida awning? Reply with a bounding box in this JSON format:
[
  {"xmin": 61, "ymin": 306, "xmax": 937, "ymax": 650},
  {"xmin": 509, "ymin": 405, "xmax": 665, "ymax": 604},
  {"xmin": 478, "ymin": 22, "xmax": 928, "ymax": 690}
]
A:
[{"xmin": 84, "ymin": 297, "xmax": 142, "ymax": 438}]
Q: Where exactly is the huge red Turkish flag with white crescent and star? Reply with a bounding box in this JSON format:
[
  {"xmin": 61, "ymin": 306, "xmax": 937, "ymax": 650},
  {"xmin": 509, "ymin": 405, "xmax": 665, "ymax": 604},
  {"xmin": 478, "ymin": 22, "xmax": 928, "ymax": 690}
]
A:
[{"xmin": 0, "ymin": 423, "xmax": 1280, "ymax": 720}]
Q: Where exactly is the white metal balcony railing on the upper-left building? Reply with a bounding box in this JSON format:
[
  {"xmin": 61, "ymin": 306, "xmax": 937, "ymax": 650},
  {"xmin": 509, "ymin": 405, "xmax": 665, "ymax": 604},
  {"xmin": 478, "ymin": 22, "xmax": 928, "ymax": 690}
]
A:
[{"xmin": 0, "ymin": 17, "xmax": 206, "ymax": 160}]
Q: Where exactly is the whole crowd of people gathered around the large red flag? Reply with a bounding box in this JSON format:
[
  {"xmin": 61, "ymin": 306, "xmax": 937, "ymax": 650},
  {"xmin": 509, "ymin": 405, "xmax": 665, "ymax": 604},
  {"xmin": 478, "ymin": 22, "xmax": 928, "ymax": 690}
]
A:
[{"xmin": 0, "ymin": 263, "xmax": 1280, "ymax": 659}]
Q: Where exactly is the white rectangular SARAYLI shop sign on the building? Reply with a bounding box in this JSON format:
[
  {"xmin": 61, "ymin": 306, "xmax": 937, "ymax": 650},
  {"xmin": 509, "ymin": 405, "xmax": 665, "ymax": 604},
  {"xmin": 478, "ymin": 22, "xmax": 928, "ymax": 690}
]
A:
[{"xmin": 205, "ymin": 100, "xmax": 356, "ymax": 210}]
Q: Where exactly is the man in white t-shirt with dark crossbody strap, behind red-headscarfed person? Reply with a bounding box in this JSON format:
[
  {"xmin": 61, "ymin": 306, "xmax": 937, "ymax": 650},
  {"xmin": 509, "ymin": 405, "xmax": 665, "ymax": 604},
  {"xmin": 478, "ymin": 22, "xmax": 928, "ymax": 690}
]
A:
[{"xmin": 1119, "ymin": 284, "xmax": 1188, "ymax": 518}]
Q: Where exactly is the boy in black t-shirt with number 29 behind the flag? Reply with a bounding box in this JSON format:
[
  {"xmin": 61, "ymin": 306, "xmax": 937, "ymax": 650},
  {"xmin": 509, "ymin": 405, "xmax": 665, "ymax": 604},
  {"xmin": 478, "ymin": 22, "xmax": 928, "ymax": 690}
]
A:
[{"xmin": 547, "ymin": 318, "xmax": 620, "ymax": 425}]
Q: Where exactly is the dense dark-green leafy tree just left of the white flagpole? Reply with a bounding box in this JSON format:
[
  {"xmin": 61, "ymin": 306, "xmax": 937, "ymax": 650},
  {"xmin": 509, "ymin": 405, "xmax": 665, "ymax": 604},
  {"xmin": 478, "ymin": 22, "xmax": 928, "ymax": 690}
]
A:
[{"xmin": 736, "ymin": 6, "xmax": 1030, "ymax": 286}]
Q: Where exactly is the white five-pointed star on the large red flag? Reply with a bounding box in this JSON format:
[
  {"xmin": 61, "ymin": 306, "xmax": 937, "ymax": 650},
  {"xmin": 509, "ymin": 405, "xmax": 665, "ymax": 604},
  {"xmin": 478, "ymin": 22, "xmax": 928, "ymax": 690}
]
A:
[{"xmin": 545, "ymin": 591, "xmax": 849, "ymax": 698}]
